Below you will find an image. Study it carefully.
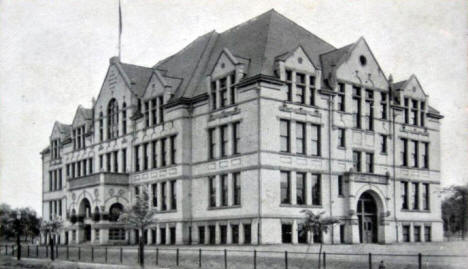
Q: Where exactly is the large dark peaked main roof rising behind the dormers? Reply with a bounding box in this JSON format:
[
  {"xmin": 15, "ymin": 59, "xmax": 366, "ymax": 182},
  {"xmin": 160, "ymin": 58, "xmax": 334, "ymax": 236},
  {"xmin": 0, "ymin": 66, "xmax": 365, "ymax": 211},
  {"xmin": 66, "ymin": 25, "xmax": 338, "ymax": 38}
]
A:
[{"xmin": 155, "ymin": 10, "xmax": 334, "ymax": 98}]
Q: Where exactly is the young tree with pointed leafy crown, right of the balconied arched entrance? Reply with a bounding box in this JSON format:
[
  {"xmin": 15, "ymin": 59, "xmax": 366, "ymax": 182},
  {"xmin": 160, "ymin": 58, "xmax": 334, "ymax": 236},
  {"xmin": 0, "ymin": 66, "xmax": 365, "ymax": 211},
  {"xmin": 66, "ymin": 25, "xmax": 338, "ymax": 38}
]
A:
[{"xmin": 119, "ymin": 187, "xmax": 157, "ymax": 267}]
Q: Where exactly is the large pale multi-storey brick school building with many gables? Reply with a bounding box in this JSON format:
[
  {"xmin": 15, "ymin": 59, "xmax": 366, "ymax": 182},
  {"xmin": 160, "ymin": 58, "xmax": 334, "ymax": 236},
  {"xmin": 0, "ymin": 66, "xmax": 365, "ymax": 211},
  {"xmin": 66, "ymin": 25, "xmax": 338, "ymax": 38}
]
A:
[{"xmin": 42, "ymin": 10, "xmax": 442, "ymax": 244}]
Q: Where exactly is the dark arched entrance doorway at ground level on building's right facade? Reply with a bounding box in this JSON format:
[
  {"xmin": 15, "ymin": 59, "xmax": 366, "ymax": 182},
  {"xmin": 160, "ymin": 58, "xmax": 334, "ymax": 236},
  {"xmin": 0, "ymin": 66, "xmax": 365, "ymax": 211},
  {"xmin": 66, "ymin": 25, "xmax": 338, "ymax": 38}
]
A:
[{"xmin": 356, "ymin": 192, "xmax": 378, "ymax": 243}]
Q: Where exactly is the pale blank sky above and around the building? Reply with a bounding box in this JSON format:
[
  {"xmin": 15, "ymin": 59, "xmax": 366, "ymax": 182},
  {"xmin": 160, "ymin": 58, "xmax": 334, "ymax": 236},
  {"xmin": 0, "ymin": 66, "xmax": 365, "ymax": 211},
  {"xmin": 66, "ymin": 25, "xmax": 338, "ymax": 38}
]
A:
[{"xmin": 0, "ymin": 0, "xmax": 468, "ymax": 214}]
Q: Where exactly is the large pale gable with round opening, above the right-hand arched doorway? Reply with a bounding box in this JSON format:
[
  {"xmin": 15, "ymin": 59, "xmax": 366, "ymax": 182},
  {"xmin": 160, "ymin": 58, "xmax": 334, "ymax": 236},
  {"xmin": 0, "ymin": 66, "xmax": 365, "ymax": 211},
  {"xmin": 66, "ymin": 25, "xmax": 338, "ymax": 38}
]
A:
[{"xmin": 336, "ymin": 38, "xmax": 388, "ymax": 89}]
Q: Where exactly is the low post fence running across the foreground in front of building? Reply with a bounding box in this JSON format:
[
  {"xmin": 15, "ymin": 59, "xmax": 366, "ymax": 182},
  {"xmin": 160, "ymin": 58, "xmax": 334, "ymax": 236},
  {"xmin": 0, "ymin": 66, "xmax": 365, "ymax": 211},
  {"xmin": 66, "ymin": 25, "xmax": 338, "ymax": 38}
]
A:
[{"xmin": 0, "ymin": 245, "xmax": 468, "ymax": 269}]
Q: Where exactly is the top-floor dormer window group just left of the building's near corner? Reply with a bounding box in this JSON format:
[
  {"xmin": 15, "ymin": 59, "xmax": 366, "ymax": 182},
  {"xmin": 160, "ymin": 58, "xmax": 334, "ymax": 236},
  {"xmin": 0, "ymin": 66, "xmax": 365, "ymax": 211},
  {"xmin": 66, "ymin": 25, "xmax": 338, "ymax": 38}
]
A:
[{"xmin": 210, "ymin": 73, "xmax": 236, "ymax": 110}]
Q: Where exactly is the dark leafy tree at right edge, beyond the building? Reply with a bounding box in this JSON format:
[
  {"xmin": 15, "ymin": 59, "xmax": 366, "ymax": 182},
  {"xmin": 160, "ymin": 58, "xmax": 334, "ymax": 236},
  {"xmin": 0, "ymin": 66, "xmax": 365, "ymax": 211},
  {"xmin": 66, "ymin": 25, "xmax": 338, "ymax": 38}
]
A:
[{"xmin": 442, "ymin": 184, "xmax": 468, "ymax": 239}]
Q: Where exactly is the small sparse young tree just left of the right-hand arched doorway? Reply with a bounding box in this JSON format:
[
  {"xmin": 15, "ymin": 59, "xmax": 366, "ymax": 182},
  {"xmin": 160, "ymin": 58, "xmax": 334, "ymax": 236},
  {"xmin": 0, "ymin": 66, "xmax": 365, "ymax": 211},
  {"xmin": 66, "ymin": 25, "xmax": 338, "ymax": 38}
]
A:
[{"xmin": 301, "ymin": 209, "xmax": 340, "ymax": 269}]
